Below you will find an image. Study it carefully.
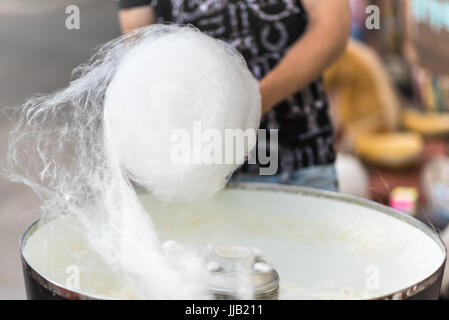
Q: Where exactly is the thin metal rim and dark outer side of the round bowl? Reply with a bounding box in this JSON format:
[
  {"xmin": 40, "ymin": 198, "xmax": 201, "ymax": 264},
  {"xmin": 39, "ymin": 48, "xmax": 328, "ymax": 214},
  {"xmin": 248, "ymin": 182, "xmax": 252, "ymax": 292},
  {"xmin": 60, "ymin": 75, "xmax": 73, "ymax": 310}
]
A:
[{"xmin": 20, "ymin": 183, "xmax": 446, "ymax": 299}]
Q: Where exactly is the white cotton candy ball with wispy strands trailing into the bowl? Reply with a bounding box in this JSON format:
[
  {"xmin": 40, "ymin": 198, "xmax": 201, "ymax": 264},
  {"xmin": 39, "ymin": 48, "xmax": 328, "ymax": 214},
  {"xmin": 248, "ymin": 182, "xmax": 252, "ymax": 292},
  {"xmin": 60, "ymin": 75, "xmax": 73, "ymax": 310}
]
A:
[{"xmin": 3, "ymin": 25, "xmax": 261, "ymax": 299}]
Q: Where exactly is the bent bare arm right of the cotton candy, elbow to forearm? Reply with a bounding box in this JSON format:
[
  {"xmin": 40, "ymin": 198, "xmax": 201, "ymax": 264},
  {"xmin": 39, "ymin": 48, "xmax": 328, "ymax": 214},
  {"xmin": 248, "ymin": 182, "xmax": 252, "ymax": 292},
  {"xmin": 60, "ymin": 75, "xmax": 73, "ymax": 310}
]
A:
[{"xmin": 260, "ymin": 0, "xmax": 351, "ymax": 113}]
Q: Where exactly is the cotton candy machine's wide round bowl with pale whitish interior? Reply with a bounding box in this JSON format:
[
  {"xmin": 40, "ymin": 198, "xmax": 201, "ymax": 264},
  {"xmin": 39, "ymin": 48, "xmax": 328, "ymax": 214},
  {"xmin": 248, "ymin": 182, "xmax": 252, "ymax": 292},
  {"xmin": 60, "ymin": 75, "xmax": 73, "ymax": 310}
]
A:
[{"xmin": 21, "ymin": 184, "xmax": 446, "ymax": 299}]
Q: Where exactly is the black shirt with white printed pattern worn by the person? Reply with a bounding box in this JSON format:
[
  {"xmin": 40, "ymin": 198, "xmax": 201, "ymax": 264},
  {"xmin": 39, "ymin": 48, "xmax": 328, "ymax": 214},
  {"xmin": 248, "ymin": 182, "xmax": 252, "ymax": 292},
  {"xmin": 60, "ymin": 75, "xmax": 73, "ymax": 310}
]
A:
[{"xmin": 118, "ymin": 0, "xmax": 335, "ymax": 173}]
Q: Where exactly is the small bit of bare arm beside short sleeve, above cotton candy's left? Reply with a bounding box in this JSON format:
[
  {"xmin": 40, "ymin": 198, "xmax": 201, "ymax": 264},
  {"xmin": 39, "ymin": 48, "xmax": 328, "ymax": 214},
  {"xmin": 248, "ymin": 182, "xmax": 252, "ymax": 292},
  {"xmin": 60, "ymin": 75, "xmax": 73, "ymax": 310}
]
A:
[{"xmin": 118, "ymin": 1, "xmax": 156, "ymax": 34}]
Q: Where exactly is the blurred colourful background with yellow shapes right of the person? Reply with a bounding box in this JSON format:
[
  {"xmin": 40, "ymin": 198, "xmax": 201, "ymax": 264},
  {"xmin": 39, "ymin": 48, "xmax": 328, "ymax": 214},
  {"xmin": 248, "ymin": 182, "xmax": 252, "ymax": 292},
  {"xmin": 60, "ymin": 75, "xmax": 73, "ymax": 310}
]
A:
[{"xmin": 325, "ymin": 0, "xmax": 449, "ymax": 230}]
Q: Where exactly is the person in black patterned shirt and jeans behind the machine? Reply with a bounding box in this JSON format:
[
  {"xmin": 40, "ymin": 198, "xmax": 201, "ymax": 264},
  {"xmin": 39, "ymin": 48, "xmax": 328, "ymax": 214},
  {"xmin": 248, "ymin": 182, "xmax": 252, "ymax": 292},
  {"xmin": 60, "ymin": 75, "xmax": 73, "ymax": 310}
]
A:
[{"xmin": 117, "ymin": 0, "xmax": 351, "ymax": 191}]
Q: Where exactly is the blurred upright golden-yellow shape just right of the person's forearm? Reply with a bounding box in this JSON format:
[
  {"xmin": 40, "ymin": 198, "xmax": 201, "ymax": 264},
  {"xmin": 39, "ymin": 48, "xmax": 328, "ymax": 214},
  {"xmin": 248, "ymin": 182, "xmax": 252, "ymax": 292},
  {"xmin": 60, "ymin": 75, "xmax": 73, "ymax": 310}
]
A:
[{"xmin": 324, "ymin": 40, "xmax": 401, "ymax": 136}]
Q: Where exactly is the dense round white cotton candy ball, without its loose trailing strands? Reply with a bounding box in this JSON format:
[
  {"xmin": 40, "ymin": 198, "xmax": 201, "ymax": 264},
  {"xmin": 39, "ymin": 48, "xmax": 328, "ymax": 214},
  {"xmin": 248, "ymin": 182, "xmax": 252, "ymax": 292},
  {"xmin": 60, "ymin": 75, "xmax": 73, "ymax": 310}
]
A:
[{"xmin": 105, "ymin": 27, "xmax": 261, "ymax": 201}]
